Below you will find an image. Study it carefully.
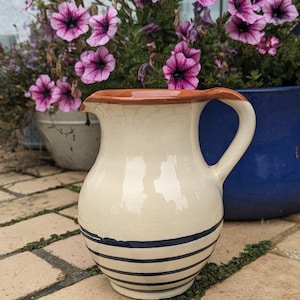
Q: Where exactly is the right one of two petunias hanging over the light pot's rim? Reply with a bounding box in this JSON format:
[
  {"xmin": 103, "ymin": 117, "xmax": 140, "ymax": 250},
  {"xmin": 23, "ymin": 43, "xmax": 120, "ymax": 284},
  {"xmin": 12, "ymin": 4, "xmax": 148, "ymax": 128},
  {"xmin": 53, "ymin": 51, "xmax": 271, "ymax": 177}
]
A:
[{"xmin": 54, "ymin": 80, "xmax": 81, "ymax": 112}]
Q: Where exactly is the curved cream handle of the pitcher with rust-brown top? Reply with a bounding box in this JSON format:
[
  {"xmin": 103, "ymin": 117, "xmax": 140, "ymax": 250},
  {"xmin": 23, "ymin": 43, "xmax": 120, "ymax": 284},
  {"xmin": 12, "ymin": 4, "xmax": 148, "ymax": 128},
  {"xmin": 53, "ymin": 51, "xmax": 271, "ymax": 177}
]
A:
[{"xmin": 202, "ymin": 88, "xmax": 256, "ymax": 183}]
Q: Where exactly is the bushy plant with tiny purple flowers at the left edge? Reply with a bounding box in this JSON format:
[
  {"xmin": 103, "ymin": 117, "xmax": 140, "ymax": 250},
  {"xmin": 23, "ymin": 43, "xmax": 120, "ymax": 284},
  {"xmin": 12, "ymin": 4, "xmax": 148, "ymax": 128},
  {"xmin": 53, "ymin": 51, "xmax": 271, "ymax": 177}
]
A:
[{"xmin": 0, "ymin": 24, "xmax": 47, "ymax": 144}]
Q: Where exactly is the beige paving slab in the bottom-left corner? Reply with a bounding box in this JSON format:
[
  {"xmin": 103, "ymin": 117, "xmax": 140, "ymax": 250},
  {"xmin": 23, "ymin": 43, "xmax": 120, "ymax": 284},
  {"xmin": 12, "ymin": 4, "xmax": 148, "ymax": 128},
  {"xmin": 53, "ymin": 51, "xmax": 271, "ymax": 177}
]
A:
[{"xmin": 0, "ymin": 252, "xmax": 63, "ymax": 300}]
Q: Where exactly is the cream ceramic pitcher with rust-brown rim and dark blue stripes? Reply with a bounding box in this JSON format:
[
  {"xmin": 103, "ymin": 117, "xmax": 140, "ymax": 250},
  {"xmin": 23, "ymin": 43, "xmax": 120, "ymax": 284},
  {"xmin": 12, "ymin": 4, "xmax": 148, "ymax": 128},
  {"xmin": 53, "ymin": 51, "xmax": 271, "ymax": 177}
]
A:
[{"xmin": 79, "ymin": 88, "xmax": 255, "ymax": 299}]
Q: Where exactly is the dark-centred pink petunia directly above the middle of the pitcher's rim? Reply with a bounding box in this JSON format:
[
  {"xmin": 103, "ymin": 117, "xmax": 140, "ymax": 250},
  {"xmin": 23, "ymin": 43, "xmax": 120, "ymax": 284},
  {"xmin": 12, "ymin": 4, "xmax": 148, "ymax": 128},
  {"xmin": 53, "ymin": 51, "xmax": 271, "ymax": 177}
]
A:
[{"xmin": 163, "ymin": 53, "xmax": 201, "ymax": 90}]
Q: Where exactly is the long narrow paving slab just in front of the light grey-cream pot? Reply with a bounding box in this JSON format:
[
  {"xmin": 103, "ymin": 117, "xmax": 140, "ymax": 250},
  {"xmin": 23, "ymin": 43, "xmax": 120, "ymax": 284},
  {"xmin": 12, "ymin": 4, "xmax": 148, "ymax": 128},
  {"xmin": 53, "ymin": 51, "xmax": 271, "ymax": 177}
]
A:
[{"xmin": 3, "ymin": 171, "xmax": 86, "ymax": 195}]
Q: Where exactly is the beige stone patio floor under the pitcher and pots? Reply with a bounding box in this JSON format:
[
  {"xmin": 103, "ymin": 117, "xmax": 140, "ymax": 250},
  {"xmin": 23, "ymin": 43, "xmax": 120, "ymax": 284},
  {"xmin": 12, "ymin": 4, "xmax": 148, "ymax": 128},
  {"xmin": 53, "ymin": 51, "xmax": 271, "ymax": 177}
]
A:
[{"xmin": 0, "ymin": 151, "xmax": 300, "ymax": 300}]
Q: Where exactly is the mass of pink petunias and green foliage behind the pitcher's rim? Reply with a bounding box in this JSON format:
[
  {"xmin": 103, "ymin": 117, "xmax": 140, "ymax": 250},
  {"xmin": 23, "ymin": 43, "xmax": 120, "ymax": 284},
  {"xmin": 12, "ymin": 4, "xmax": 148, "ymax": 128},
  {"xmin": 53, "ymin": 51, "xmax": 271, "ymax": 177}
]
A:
[{"xmin": 20, "ymin": 0, "xmax": 300, "ymax": 112}]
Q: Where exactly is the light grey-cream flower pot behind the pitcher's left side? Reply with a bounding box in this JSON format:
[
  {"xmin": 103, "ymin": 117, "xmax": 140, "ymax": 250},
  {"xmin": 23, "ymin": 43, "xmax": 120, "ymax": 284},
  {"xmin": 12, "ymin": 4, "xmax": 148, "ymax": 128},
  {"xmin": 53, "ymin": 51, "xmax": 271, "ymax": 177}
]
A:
[{"xmin": 35, "ymin": 111, "xmax": 100, "ymax": 171}]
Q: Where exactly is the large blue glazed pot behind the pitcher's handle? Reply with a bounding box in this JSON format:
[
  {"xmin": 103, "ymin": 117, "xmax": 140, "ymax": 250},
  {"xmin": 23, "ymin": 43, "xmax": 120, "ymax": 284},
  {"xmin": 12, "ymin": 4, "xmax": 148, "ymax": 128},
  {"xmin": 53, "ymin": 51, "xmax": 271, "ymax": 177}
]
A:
[{"xmin": 199, "ymin": 86, "xmax": 300, "ymax": 220}]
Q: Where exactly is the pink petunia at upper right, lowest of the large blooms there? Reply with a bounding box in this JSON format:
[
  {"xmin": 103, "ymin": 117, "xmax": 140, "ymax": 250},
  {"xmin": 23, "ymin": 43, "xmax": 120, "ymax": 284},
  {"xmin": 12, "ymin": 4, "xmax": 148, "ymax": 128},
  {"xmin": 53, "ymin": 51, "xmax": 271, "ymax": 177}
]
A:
[{"xmin": 225, "ymin": 16, "xmax": 266, "ymax": 45}]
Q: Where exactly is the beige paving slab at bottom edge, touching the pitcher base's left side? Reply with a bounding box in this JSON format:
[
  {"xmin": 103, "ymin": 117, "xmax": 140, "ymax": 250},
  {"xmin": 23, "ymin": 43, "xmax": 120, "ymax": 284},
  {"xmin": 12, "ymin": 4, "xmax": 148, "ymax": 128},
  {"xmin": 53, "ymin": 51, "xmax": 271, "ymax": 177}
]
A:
[{"xmin": 40, "ymin": 275, "xmax": 131, "ymax": 300}]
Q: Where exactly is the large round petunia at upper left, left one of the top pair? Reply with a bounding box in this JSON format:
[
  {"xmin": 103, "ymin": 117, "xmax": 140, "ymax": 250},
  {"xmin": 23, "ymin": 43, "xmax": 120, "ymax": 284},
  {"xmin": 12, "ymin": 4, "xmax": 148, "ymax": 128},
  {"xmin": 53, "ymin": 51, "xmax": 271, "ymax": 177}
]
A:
[{"xmin": 50, "ymin": 2, "xmax": 90, "ymax": 42}]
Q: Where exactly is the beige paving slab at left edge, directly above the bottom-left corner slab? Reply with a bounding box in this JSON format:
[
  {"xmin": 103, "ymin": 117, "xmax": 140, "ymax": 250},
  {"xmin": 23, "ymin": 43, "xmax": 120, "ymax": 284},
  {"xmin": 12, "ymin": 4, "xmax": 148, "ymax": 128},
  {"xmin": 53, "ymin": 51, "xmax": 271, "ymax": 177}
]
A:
[{"xmin": 0, "ymin": 213, "xmax": 78, "ymax": 255}]
